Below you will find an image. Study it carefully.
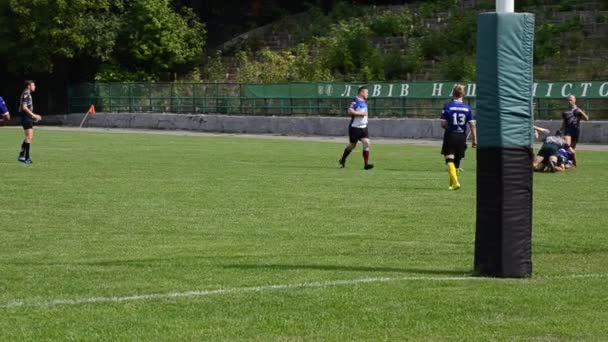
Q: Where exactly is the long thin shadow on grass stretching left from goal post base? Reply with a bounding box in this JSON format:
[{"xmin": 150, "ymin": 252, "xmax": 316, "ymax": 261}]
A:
[{"xmin": 223, "ymin": 264, "xmax": 472, "ymax": 276}]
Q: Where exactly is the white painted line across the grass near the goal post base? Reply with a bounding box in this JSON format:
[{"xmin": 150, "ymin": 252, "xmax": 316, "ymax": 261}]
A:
[{"xmin": 0, "ymin": 274, "xmax": 608, "ymax": 309}]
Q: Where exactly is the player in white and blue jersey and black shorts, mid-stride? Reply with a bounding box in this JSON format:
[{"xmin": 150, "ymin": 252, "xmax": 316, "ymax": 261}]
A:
[{"xmin": 338, "ymin": 87, "xmax": 374, "ymax": 170}]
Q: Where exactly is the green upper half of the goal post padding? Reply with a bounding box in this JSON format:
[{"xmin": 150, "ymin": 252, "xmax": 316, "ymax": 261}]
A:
[{"xmin": 477, "ymin": 13, "xmax": 534, "ymax": 148}]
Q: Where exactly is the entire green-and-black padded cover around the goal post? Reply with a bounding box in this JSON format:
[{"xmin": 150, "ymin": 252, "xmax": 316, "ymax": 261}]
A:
[{"xmin": 475, "ymin": 13, "xmax": 534, "ymax": 278}]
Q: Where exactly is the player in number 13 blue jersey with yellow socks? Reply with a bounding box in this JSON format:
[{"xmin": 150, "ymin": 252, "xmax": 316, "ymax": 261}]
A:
[{"xmin": 441, "ymin": 84, "xmax": 477, "ymax": 190}]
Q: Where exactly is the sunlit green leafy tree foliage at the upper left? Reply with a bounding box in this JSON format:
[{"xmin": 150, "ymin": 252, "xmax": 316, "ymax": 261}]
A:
[{"xmin": 0, "ymin": 0, "xmax": 205, "ymax": 79}]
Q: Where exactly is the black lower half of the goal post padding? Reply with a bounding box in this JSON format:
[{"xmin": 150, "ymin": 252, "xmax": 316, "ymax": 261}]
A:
[{"xmin": 475, "ymin": 147, "xmax": 533, "ymax": 278}]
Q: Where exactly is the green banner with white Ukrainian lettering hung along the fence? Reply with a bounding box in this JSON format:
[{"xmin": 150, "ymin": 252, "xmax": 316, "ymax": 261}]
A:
[{"xmin": 243, "ymin": 81, "xmax": 608, "ymax": 99}]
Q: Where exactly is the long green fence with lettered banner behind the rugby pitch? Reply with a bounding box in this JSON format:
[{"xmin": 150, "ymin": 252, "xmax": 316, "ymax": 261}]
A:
[{"xmin": 68, "ymin": 81, "xmax": 608, "ymax": 120}]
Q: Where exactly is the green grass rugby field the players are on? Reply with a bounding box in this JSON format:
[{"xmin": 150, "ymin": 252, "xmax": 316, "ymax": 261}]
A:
[{"xmin": 0, "ymin": 129, "xmax": 608, "ymax": 341}]
